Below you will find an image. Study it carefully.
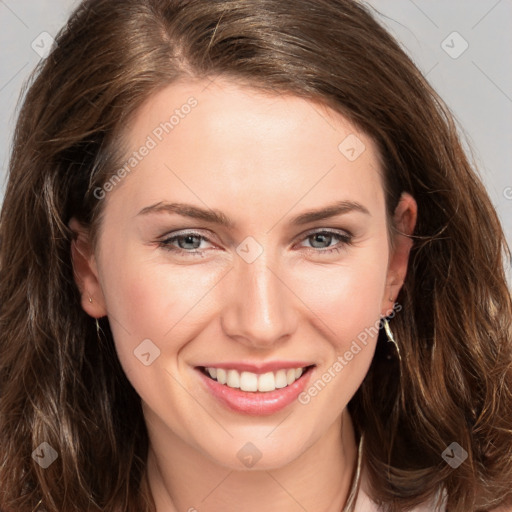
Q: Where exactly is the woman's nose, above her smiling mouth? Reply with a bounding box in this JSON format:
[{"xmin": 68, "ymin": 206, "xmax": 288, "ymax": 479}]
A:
[{"xmin": 221, "ymin": 251, "xmax": 297, "ymax": 349}]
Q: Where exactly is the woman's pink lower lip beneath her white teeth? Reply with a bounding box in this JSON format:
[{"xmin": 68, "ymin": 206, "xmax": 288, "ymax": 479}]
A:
[{"xmin": 197, "ymin": 368, "xmax": 313, "ymax": 416}]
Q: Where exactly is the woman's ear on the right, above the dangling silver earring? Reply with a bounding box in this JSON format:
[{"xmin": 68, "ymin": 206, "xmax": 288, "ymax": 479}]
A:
[{"xmin": 381, "ymin": 192, "xmax": 418, "ymax": 316}]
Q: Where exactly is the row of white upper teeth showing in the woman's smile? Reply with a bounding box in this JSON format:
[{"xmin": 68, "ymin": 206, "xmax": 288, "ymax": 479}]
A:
[{"xmin": 206, "ymin": 368, "xmax": 304, "ymax": 392}]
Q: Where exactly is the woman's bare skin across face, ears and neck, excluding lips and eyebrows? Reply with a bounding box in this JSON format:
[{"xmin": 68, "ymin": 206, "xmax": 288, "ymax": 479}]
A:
[{"xmin": 70, "ymin": 78, "xmax": 416, "ymax": 512}]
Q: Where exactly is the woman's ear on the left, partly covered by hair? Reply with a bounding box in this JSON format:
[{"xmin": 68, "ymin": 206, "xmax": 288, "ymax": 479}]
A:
[{"xmin": 68, "ymin": 217, "xmax": 107, "ymax": 318}]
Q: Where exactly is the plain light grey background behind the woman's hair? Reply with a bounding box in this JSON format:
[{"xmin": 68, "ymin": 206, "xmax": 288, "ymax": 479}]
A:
[{"xmin": 0, "ymin": 0, "xmax": 512, "ymax": 266}]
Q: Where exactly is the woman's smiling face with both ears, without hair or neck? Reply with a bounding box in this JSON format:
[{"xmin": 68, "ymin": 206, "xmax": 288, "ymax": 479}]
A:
[{"xmin": 72, "ymin": 79, "xmax": 415, "ymax": 468}]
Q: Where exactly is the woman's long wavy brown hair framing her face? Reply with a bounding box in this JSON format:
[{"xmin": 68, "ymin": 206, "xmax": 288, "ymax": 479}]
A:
[{"xmin": 0, "ymin": 0, "xmax": 512, "ymax": 512}]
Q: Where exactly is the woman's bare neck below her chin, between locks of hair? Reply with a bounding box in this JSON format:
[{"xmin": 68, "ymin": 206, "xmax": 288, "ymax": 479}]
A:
[{"xmin": 146, "ymin": 409, "xmax": 357, "ymax": 512}]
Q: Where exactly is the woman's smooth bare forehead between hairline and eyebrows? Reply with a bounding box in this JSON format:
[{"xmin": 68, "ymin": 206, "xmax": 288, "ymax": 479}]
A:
[{"xmin": 110, "ymin": 79, "xmax": 383, "ymax": 220}]
